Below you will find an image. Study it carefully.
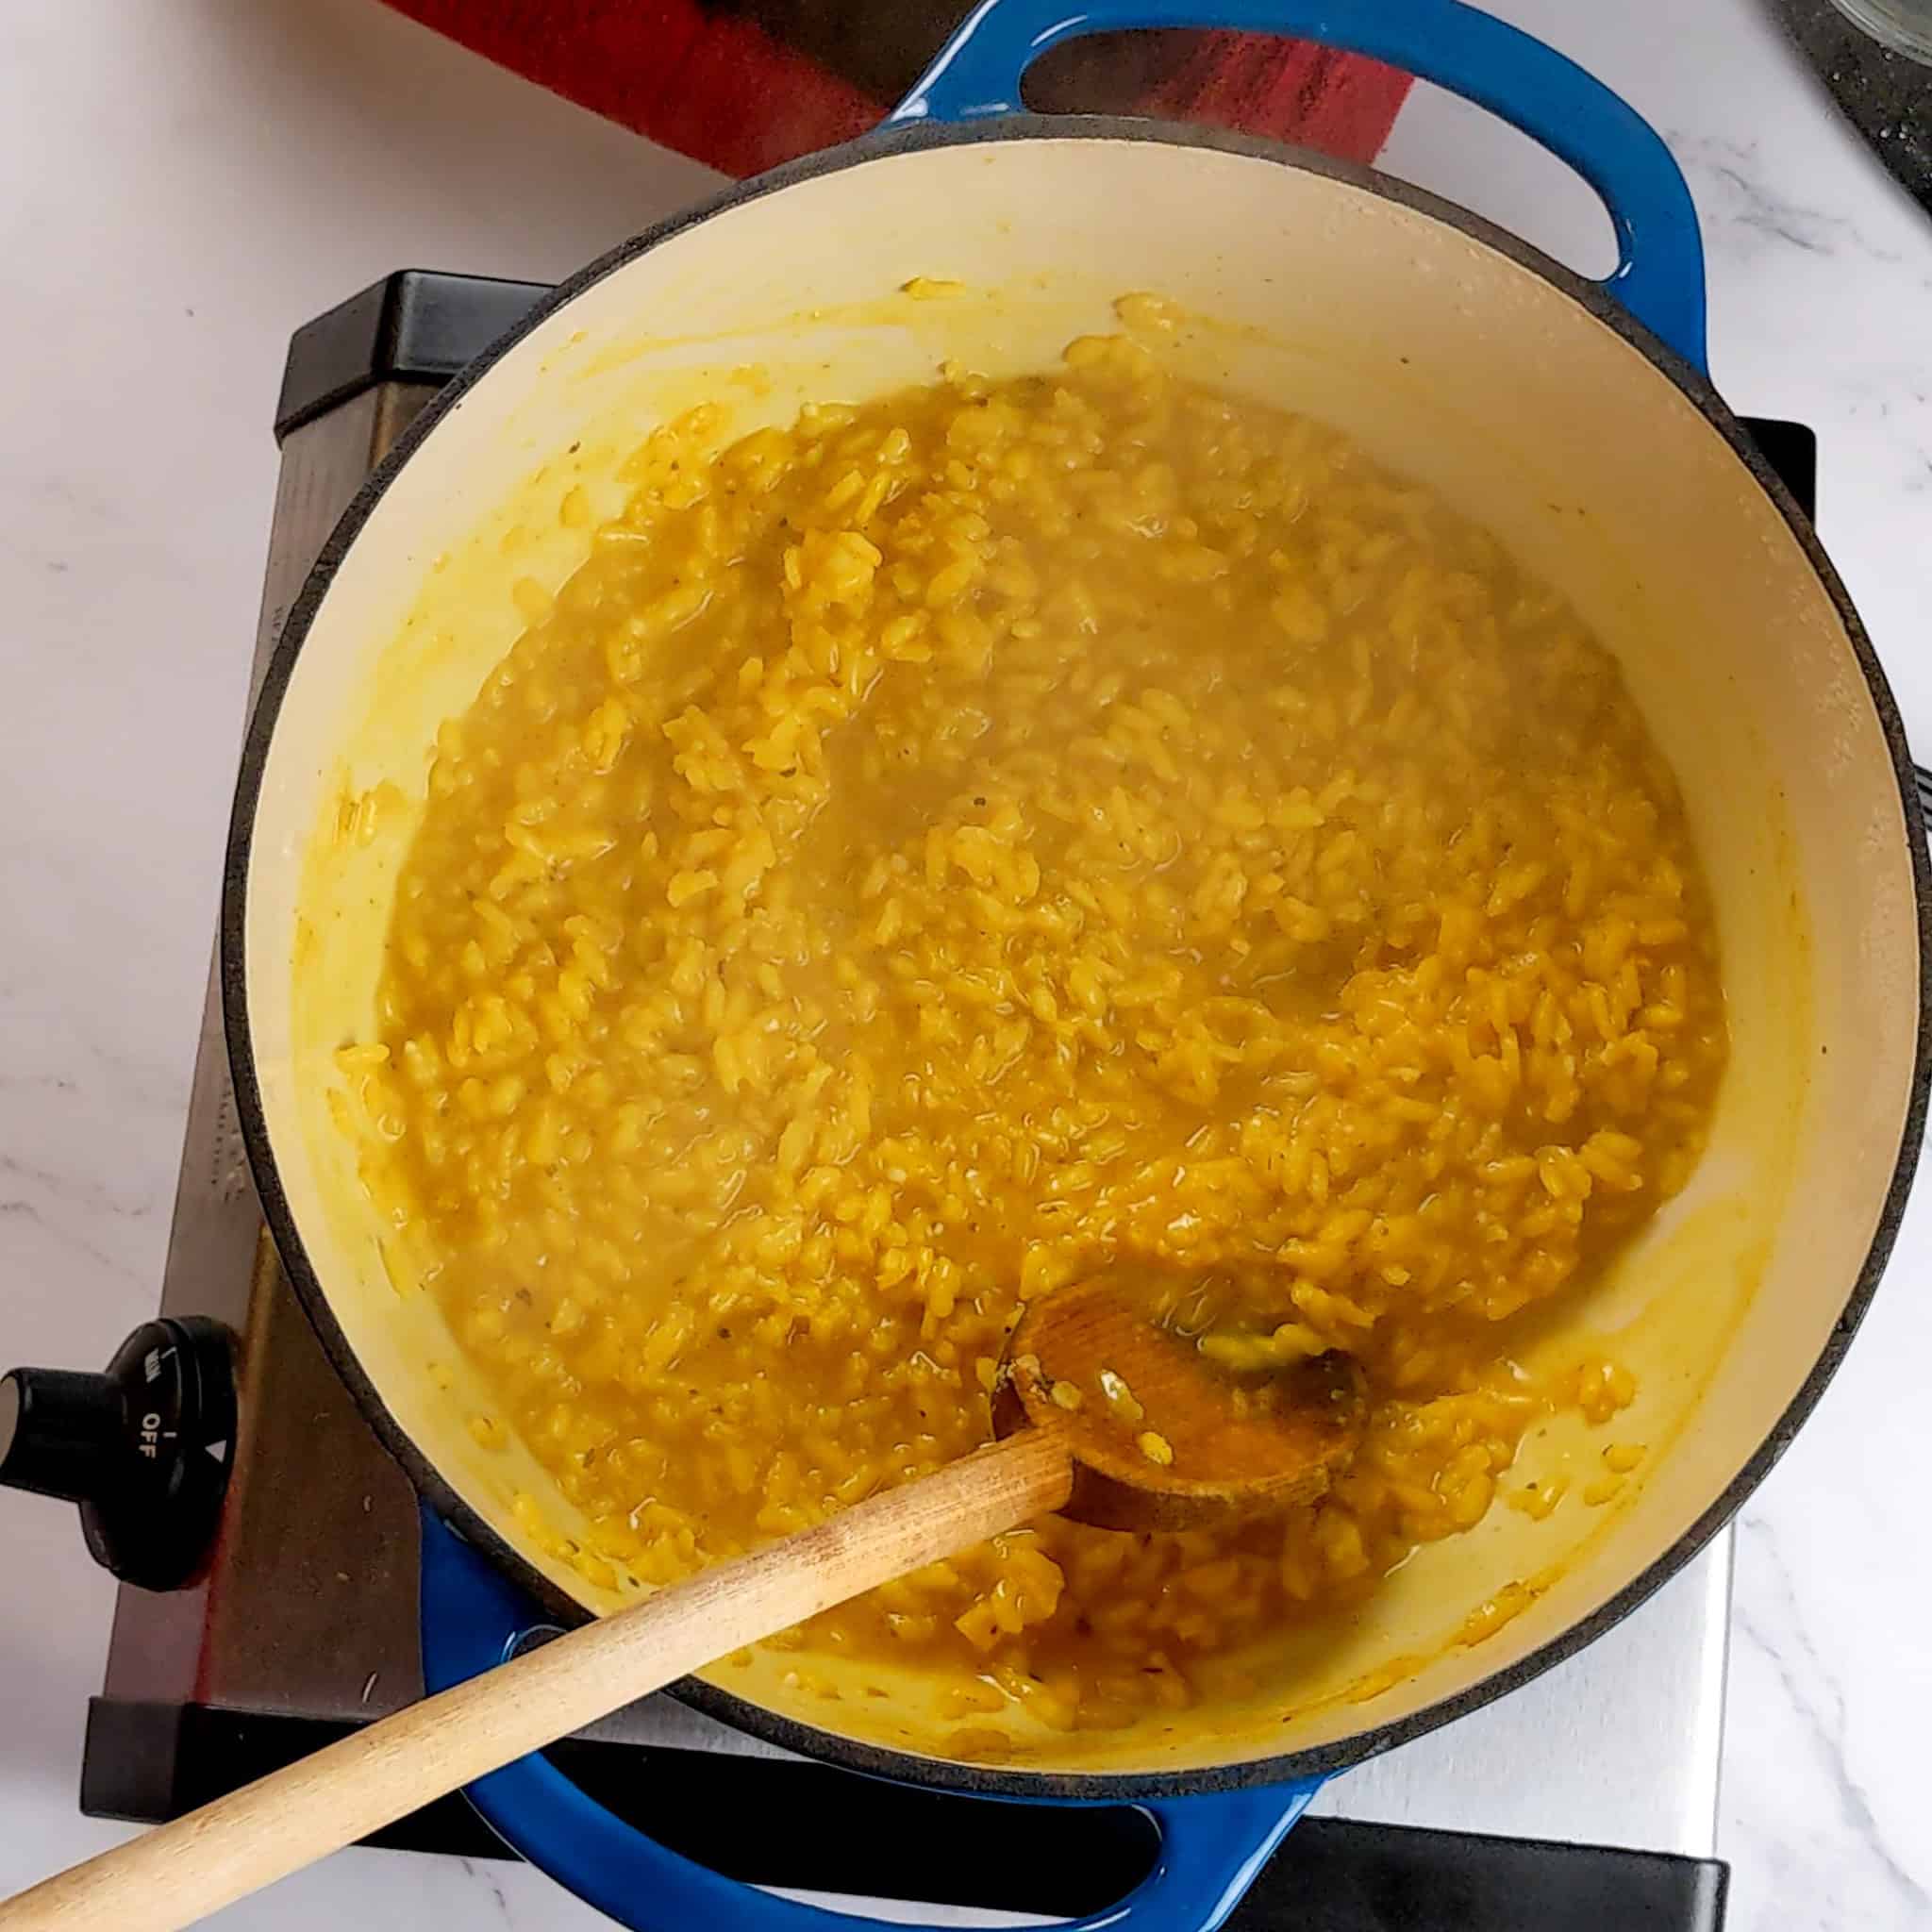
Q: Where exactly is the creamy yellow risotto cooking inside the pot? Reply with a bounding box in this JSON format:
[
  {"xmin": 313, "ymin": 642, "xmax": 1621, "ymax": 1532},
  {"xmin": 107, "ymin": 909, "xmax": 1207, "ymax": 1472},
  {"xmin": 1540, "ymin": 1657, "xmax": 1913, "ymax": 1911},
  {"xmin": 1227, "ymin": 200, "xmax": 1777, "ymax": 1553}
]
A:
[{"xmin": 346, "ymin": 316, "xmax": 1725, "ymax": 1748}]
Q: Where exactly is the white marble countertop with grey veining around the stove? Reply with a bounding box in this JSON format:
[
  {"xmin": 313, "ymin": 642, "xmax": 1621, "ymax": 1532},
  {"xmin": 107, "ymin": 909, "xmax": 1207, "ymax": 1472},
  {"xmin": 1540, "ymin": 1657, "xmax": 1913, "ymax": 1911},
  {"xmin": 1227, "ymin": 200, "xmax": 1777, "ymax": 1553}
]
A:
[{"xmin": 0, "ymin": 0, "xmax": 1932, "ymax": 1932}]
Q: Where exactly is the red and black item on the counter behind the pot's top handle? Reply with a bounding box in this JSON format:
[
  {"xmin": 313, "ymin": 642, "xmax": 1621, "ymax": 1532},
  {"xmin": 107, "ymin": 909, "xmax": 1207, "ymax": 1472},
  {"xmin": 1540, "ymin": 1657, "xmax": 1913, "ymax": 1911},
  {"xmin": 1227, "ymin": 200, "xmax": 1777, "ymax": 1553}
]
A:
[{"xmin": 389, "ymin": 0, "xmax": 1408, "ymax": 175}]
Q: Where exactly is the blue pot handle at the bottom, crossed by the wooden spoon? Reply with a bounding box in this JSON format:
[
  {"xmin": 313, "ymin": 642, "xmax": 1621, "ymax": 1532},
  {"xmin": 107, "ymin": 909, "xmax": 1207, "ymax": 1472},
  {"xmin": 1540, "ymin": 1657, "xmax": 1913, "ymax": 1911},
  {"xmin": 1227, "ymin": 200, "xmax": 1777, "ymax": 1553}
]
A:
[{"xmin": 421, "ymin": 1508, "xmax": 1322, "ymax": 1932}]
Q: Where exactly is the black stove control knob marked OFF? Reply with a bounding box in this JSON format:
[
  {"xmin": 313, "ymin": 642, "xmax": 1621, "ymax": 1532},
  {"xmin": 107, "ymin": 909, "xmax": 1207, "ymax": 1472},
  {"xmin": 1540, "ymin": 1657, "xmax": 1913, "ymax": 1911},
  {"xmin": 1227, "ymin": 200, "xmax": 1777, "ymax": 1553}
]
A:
[{"xmin": 0, "ymin": 1316, "xmax": 236, "ymax": 1591}]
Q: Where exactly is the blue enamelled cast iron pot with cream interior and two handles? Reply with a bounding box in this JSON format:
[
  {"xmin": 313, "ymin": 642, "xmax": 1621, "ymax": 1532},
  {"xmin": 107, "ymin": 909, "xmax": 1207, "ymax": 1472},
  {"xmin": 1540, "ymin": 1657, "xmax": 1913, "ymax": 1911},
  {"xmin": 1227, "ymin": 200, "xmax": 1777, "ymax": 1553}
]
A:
[{"xmin": 223, "ymin": 0, "xmax": 1926, "ymax": 1932}]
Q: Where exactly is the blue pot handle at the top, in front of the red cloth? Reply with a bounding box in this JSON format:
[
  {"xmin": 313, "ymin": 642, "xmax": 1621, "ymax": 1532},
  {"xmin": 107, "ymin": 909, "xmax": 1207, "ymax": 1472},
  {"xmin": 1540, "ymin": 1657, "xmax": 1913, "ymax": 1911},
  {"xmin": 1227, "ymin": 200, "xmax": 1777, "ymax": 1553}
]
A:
[{"xmin": 892, "ymin": 0, "xmax": 1706, "ymax": 371}]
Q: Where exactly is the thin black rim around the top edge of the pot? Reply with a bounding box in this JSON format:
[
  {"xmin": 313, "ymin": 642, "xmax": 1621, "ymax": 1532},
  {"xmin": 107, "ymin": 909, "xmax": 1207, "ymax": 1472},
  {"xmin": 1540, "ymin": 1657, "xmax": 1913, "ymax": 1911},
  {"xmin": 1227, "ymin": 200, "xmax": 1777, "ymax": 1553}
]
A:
[{"xmin": 220, "ymin": 114, "xmax": 1932, "ymax": 1803}]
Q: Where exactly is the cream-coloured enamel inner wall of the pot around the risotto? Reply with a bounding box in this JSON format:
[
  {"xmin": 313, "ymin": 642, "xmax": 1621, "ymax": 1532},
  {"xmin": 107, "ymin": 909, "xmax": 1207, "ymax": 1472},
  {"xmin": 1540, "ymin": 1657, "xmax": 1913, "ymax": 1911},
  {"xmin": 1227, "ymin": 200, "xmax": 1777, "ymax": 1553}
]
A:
[{"xmin": 245, "ymin": 135, "xmax": 1919, "ymax": 1774}]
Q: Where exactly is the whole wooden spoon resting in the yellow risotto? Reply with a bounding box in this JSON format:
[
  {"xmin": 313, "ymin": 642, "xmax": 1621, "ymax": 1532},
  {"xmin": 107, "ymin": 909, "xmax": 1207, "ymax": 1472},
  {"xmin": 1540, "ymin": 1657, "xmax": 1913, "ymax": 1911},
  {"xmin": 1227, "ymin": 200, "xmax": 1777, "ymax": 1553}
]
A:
[{"xmin": 0, "ymin": 1279, "xmax": 1366, "ymax": 1932}]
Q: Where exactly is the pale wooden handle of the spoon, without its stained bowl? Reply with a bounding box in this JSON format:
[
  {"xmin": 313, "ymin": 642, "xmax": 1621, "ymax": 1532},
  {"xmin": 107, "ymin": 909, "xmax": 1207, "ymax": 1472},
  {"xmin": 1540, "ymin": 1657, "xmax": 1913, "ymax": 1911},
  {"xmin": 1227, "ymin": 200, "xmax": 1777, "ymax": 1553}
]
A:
[{"xmin": 0, "ymin": 1430, "xmax": 1073, "ymax": 1932}]
